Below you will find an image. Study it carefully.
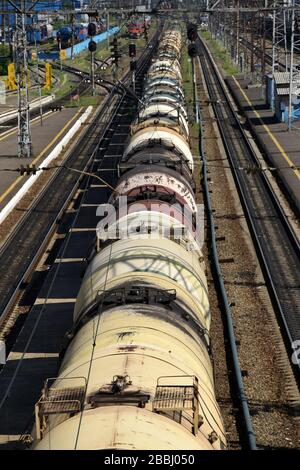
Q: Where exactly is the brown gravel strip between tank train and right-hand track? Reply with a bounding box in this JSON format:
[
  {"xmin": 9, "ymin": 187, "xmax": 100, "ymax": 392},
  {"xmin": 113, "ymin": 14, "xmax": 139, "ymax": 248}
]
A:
[{"xmin": 197, "ymin": 53, "xmax": 300, "ymax": 449}]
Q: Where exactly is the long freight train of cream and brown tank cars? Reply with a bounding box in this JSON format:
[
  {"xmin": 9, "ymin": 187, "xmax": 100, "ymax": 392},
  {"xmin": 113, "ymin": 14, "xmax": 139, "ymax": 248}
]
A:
[{"xmin": 33, "ymin": 25, "xmax": 226, "ymax": 450}]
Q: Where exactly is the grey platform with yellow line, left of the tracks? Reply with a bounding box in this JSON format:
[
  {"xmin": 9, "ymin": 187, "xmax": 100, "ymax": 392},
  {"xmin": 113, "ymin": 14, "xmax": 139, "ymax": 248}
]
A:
[{"xmin": 0, "ymin": 107, "xmax": 84, "ymax": 210}]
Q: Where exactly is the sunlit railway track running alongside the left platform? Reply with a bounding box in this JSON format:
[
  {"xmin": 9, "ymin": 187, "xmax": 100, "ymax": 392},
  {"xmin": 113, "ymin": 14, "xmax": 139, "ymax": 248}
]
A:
[{"xmin": 0, "ymin": 28, "xmax": 159, "ymax": 342}]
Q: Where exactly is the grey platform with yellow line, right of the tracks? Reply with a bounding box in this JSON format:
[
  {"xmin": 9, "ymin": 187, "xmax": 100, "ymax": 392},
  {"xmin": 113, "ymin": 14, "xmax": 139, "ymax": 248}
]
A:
[{"xmin": 227, "ymin": 77, "xmax": 300, "ymax": 213}]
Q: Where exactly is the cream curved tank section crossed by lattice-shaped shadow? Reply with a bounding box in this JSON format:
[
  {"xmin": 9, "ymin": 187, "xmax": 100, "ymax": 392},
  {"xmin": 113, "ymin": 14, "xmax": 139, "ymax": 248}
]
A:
[{"xmin": 74, "ymin": 239, "xmax": 210, "ymax": 330}]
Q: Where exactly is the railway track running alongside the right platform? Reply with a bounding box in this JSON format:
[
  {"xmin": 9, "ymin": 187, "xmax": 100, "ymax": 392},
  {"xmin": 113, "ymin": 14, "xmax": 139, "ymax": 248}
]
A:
[{"xmin": 198, "ymin": 38, "xmax": 300, "ymax": 381}]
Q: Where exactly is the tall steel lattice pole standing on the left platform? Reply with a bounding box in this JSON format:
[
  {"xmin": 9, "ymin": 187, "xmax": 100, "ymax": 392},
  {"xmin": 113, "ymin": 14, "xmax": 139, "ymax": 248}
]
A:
[{"xmin": 14, "ymin": 0, "xmax": 31, "ymax": 158}]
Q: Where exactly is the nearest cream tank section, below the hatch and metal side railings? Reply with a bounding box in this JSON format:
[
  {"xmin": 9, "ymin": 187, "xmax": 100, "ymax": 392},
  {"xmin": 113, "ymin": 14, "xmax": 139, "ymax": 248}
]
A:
[{"xmin": 32, "ymin": 406, "xmax": 213, "ymax": 450}]
